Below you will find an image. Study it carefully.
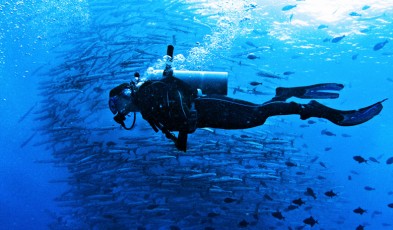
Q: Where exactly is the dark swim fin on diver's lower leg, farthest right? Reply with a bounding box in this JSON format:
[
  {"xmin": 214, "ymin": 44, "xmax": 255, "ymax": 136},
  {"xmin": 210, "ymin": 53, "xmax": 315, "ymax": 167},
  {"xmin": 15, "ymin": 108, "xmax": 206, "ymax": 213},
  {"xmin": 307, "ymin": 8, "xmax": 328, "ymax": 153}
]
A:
[{"xmin": 300, "ymin": 99, "xmax": 387, "ymax": 126}]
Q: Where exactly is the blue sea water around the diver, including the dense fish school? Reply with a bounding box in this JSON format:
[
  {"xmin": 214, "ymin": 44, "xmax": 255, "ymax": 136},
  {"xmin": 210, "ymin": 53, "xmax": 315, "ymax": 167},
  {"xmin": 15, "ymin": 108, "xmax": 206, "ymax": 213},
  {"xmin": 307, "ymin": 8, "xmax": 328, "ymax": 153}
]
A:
[{"xmin": 0, "ymin": 0, "xmax": 393, "ymax": 229}]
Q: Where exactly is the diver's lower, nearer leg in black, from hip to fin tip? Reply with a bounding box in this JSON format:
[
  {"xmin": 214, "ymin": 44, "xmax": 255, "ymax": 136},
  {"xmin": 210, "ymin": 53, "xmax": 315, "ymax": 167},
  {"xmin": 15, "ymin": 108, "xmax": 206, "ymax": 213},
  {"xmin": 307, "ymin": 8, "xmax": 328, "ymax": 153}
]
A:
[{"xmin": 195, "ymin": 96, "xmax": 386, "ymax": 129}]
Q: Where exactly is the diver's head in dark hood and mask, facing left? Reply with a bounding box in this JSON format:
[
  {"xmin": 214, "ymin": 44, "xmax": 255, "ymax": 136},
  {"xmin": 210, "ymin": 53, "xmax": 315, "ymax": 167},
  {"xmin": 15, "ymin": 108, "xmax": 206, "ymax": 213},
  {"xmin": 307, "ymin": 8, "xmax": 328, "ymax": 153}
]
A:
[{"xmin": 109, "ymin": 83, "xmax": 138, "ymax": 116}]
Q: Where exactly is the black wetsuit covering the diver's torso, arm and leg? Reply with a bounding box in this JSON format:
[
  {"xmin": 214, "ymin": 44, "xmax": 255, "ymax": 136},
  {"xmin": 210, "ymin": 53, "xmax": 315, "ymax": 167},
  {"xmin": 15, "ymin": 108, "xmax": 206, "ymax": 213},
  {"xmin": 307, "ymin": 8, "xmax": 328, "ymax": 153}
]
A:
[{"xmin": 135, "ymin": 77, "xmax": 301, "ymax": 151}]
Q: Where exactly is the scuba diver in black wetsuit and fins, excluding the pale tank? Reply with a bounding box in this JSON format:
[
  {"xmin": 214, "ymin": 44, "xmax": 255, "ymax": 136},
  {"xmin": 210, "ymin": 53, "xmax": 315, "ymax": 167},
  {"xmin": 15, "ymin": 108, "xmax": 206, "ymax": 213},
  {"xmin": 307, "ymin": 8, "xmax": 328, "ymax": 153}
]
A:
[{"xmin": 109, "ymin": 46, "xmax": 387, "ymax": 152}]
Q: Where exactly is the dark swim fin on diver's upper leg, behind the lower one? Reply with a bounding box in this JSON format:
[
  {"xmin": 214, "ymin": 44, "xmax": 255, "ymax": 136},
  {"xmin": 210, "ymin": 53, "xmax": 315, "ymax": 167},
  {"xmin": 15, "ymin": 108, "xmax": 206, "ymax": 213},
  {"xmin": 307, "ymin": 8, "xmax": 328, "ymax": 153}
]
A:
[{"xmin": 272, "ymin": 83, "xmax": 344, "ymax": 101}]
